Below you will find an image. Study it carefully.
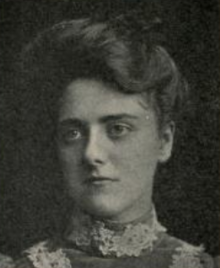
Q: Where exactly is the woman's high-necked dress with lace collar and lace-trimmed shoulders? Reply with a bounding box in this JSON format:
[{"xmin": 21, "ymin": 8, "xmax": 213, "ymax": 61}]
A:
[{"xmin": 12, "ymin": 208, "xmax": 214, "ymax": 268}]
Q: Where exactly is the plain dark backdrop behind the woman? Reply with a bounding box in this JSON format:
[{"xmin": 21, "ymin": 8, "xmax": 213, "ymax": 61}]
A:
[{"xmin": 0, "ymin": 0, "xmax": 220, "ymax": 255}]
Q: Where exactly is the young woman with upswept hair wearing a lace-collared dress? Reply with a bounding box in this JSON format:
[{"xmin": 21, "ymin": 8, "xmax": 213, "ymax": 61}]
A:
[{"xmin": 4, "ymin": 9, "xmax": 213, "ymax": 268}]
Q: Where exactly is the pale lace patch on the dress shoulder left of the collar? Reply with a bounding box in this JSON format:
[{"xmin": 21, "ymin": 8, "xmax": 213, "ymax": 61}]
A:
[{"xmin": 25, "ymin": 241, "xmax": 72, "ymax": 268}]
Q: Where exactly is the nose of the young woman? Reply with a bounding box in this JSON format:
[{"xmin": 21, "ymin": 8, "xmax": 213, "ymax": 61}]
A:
[{"xmin": 84, "ymin": 127, "xmax": 107, "ymax": 166}]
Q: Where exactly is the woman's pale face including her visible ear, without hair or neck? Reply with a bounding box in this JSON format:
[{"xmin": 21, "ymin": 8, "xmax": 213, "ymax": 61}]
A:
[{"xmin": 58, "ymin": 79, "xmax": 173, "ymax": 222}]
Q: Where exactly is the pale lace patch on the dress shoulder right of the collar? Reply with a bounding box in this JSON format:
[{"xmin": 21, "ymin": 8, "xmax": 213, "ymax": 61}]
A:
[{"xmin": 169, "ymin": 243, "xmax": 204, "ymax": 268}]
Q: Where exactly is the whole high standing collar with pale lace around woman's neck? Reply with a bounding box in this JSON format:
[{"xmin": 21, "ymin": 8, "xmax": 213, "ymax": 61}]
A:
[{"xmin": 66, "ymin": 206, "xmax": 166, "ymax": 257}]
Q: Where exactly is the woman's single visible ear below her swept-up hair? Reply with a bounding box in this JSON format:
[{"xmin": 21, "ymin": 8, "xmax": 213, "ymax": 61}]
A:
[{"xmin": 158, "ymin": 121, "xmax": 175, "ymax": 163}]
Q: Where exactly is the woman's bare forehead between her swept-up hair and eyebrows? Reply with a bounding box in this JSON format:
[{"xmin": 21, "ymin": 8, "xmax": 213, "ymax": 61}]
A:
[{"xmin": 59, "ymin": 79, "xmax": 153, "ymax": 120}]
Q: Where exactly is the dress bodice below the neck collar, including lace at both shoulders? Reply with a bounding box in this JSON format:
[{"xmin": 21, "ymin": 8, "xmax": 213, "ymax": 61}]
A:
[{"xmin": 13, "ymin": 233, "xmax": 213, "ymax": 268}]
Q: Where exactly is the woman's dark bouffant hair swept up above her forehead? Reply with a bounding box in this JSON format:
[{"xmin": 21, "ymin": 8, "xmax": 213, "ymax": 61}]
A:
[{"xmin": 20, "ymin": 9, "xmax": 187, "ymax": 137}]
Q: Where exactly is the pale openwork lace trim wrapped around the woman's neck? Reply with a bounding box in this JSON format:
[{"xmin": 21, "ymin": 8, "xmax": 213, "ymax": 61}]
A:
[{"xmin": 71, "ymin": 208, "xmax": 166, "ymax": 257}]
